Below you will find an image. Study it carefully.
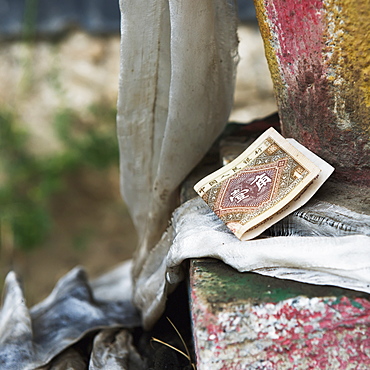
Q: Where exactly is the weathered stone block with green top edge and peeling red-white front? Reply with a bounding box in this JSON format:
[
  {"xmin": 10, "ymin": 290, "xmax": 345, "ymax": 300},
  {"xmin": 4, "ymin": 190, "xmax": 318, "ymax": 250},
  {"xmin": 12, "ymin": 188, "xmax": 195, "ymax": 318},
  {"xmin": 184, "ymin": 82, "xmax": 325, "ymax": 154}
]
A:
[{"xmin": 189, "ymin": 259, "xmax": 370, "ymax": 370}]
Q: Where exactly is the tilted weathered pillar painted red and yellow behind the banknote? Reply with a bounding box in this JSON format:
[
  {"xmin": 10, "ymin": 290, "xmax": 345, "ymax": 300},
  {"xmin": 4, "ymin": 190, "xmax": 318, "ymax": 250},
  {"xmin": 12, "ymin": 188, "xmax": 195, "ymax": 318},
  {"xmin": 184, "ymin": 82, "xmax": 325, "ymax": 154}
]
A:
[{"xmin": 255, "ymin": 0, "xmax": 370, "ymax": 186}]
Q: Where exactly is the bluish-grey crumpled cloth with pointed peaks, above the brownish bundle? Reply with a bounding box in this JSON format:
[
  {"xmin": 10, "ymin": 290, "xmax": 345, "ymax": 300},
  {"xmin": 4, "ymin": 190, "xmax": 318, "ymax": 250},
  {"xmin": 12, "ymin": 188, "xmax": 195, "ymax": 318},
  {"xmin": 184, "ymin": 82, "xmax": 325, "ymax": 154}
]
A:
[{"xmin": 0, "ymin": 263, "xmax": 141, "ymax": 370}]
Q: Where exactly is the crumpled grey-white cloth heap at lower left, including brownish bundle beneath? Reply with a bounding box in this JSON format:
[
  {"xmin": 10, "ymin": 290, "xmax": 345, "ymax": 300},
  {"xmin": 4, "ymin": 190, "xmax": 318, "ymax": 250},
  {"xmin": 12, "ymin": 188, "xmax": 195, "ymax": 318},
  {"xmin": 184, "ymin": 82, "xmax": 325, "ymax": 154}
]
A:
[{"xmin": 0, "ymin": 262, "xmax": 144, "ymax": 370}]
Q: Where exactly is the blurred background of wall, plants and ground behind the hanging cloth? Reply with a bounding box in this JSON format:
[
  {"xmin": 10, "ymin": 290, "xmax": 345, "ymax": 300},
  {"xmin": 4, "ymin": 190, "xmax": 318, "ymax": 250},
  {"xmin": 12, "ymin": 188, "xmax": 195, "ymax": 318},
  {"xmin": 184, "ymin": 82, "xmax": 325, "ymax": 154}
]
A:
[{"xmin": 0, "ymin": 0, "xmax": 276, "ymax": 305}]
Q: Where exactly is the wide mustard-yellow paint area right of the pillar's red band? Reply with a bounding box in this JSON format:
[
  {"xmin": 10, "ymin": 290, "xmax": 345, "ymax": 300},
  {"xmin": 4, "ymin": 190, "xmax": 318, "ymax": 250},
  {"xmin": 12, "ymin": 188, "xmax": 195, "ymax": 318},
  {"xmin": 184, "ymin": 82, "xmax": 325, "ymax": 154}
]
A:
[{"xmin": 324, "ymin": 0, "xmax": 370, "ymax": 134}]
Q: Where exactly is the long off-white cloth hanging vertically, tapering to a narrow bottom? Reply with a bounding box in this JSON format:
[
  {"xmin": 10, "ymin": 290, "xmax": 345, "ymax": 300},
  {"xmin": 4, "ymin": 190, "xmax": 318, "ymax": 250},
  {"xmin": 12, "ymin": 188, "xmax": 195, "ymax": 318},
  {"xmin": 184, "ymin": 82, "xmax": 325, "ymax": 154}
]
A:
[{"xmin": 117, "ymin": 0, "xmax": 238, "ymax": 280}]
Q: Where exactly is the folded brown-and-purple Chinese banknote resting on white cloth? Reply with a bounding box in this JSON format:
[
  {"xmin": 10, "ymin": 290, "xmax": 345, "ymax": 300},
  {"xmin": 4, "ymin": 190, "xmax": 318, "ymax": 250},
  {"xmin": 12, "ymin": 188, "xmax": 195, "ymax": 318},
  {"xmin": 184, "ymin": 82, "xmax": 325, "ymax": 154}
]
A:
[{"xmin": 194, "ymin": 128, "xmax": 334, "ymax": 240}]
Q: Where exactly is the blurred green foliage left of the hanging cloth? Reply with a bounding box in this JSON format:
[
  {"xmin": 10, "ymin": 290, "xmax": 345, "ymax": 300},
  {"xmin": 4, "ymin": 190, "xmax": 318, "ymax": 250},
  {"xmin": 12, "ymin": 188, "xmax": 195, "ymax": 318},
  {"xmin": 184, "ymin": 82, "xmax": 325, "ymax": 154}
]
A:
[{"xmin": 0, "ymin": 104, "xmax": 118, "ymax": 249}]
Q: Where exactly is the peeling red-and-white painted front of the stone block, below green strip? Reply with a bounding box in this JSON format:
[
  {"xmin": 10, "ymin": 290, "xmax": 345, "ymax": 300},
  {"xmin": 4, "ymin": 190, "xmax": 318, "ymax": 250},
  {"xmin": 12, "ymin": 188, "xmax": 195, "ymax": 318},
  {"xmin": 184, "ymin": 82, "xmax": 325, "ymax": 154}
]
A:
[{"xmin": 190, "ymin": 263, "xmax": 370, "ymax": 370}]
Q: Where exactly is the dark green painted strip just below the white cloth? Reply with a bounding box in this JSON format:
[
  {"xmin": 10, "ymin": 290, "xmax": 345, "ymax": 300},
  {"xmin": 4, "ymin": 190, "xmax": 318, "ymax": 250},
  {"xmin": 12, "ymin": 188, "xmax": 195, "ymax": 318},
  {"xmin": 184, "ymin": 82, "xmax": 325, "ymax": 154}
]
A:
[{"xmin": 191, "ymin": 259, "xmax": 370, "ymax": 304}]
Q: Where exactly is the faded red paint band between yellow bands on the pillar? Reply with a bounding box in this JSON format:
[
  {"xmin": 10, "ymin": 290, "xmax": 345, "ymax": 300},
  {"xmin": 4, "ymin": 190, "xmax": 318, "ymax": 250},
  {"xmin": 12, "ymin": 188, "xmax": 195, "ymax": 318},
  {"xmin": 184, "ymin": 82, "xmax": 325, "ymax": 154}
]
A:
[{"xmin": 265, "ymin": 0, "xmax": 334, "ymax": 163}]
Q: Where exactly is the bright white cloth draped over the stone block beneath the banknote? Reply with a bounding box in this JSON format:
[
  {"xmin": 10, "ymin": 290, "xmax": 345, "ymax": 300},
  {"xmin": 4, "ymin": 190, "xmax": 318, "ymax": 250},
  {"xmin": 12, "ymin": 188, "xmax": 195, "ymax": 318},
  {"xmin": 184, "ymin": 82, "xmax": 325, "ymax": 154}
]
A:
[{"xmin": 134, "ymin": 198, "xmax": 370, "ymax": 328}]
